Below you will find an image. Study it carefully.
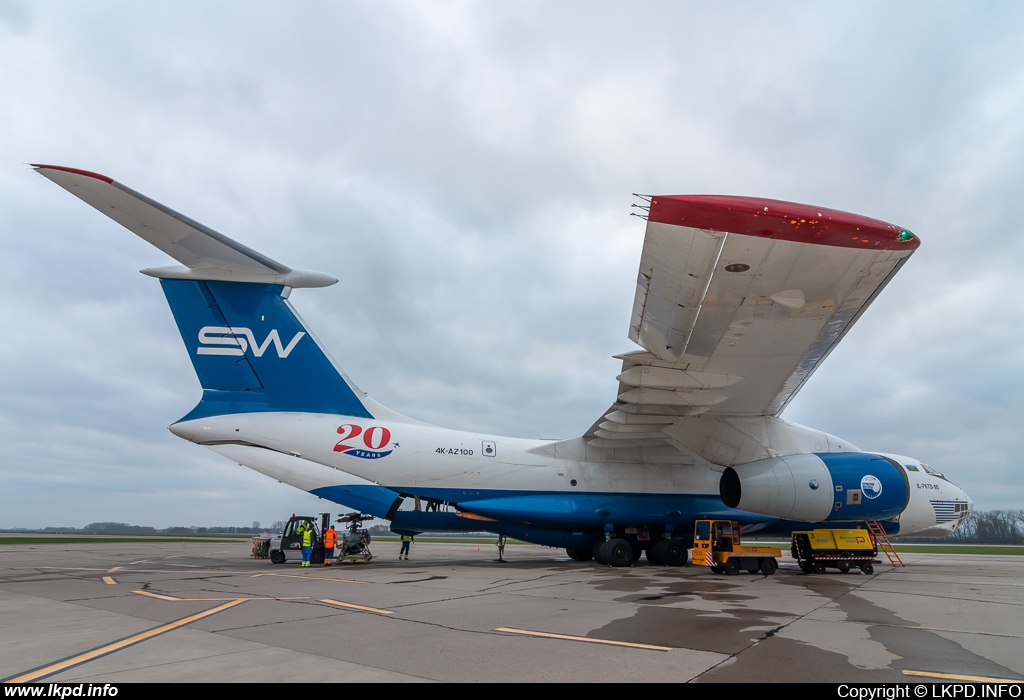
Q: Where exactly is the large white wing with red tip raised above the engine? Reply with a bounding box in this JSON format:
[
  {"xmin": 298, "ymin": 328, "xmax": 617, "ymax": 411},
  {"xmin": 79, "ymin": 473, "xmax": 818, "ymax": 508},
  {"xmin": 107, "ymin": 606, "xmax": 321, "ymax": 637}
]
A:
[{"xmin": 587, "ymin": 195, "xmax": 920, "ymax": 446}]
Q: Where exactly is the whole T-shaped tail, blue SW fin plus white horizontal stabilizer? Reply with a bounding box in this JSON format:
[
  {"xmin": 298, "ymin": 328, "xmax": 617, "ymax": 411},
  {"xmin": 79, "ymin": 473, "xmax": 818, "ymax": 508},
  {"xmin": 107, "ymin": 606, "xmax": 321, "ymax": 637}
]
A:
[{"xmin": 34, "ymin": 166, "xmax": 373, "ymax": 420}]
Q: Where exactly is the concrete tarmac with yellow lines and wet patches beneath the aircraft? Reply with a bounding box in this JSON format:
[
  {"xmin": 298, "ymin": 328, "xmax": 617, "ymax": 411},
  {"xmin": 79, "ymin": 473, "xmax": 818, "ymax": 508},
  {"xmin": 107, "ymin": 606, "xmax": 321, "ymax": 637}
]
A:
[{"xmin": 0, "ymin": 541, "xmax": 1024, "ymax": 684}]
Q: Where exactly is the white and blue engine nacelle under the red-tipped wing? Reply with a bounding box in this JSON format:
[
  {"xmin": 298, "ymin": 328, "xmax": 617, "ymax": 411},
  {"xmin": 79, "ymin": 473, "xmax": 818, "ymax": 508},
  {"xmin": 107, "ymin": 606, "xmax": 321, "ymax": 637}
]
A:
[{"xmin": 719, "ymin": 452, "xmax": 910, "ymax": 522}]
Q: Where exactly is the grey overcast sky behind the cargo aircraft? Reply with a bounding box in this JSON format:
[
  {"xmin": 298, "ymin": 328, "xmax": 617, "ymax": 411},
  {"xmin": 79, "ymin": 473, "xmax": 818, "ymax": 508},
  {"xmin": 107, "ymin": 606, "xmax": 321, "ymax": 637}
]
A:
[{"xmin": 0, "ymin": 0, "xmax": 1024, "ymax": 527}]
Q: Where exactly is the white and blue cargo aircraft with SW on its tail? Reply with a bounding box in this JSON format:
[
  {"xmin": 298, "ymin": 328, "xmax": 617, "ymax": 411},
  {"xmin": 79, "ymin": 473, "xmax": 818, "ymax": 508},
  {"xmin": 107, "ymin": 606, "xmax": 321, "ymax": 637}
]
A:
[{"xmin": 33, "ymin": 165, "xmax": 973, "ymax": 566}]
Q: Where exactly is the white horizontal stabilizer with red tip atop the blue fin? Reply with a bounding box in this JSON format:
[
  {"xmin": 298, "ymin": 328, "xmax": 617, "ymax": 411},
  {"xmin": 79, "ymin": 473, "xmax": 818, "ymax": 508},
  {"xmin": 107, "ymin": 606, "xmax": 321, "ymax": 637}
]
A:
[{"xmin": 32, "ymin": 165, "xmax": 338, "ymax": 287}]
